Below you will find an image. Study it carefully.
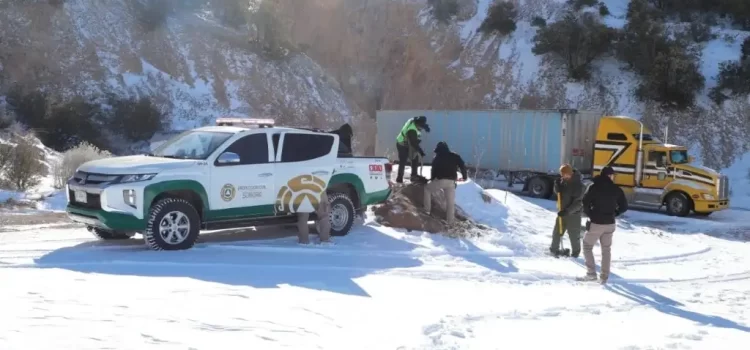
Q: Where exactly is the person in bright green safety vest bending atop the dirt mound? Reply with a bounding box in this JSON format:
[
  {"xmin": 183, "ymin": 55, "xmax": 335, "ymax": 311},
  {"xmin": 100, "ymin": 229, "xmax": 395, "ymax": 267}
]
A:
[{"xmin": 396, "ymin": 115, "xmax": 430, "ymax": 183}]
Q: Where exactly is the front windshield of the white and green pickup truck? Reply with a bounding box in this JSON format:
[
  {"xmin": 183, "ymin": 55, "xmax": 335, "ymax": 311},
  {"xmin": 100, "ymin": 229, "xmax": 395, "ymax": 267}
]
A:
[{"xmin": 151, "ymin": 131, "xmax": 233, "ymax": 159}]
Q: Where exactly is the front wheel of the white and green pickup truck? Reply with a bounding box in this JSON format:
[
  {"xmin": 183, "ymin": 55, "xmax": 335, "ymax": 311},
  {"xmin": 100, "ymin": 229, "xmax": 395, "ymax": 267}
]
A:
[{"xmin": 143, "ymin": 198, "xmax": 200, "ymax": 250}]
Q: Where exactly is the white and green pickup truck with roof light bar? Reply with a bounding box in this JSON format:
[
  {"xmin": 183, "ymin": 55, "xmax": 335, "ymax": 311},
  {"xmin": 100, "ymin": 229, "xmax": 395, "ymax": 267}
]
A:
[{"xmin": 67, "ymin": 118, "xmax": 391, "ymax": 250}]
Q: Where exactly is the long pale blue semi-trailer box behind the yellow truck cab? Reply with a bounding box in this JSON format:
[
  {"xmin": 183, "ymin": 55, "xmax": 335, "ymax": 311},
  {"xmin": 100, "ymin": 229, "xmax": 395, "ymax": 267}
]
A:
[{"xmin": 375, "ymin": 110, "xmax": 602, "ymax": 173}]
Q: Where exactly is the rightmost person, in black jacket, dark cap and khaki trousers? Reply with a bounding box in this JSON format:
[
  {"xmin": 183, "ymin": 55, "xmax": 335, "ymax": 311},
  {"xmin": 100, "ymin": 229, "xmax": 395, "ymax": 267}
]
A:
[{"xmin": 580, "ymin": 166, "xmax": 628, "ymax": 284}]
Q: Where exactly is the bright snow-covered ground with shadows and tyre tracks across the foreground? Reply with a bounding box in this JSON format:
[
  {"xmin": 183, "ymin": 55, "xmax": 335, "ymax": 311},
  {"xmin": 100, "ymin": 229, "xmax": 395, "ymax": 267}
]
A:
[{"xmin": 0, "ymin": 172, "xmax": 750, "ymax": 350}]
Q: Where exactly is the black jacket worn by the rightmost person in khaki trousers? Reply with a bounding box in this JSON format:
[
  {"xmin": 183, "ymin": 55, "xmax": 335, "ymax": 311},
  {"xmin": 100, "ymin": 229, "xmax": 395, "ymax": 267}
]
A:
[{"xmin": 583, "ymin": 175, "xmax": 628, "ymax": 225}]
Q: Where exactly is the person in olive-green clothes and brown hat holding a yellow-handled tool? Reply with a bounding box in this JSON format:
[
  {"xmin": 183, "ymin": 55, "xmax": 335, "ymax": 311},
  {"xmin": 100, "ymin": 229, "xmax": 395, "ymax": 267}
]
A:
[{"xmin": 549, "ymin": 164, "xmax": 583, "ymax": 258}]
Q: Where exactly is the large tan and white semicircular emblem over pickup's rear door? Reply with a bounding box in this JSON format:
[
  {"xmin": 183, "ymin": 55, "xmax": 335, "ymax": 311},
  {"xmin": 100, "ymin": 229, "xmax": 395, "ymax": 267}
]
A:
[{"xmin": 276, "ymin": 175, "xmax": 326, "ymax": 213}]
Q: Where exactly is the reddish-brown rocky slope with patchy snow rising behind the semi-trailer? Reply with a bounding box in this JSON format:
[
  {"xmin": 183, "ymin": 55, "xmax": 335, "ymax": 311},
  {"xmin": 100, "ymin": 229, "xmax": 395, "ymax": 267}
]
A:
[{"xmin": 278, "ymin": 0, "xmax": 750, "ymax": 167}]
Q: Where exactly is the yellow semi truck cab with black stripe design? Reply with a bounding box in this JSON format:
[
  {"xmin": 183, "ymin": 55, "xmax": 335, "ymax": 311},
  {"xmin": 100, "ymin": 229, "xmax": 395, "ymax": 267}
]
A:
[{"xmin": 593, "ymin": 116, "xmax": 729, "ymax": 216}]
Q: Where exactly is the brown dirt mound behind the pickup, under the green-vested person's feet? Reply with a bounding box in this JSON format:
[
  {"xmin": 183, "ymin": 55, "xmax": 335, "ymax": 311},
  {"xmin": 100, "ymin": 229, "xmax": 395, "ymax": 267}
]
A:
[{"xmin": 373, "ymin": 184, "xmax": 490, "ymax": 237}]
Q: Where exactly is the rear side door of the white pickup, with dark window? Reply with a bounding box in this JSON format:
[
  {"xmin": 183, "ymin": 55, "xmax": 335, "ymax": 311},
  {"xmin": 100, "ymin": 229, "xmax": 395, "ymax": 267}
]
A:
[{"xmin": 273, "ymin": 130, "xmax": 339, "ymax": 215}]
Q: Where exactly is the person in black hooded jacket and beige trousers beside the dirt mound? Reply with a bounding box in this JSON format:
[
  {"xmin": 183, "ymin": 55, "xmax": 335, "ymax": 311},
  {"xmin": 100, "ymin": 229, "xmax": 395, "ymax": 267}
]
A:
[{"xmin": 424, "ymin": 141, "xmax": 467, "ymax": 224}]
